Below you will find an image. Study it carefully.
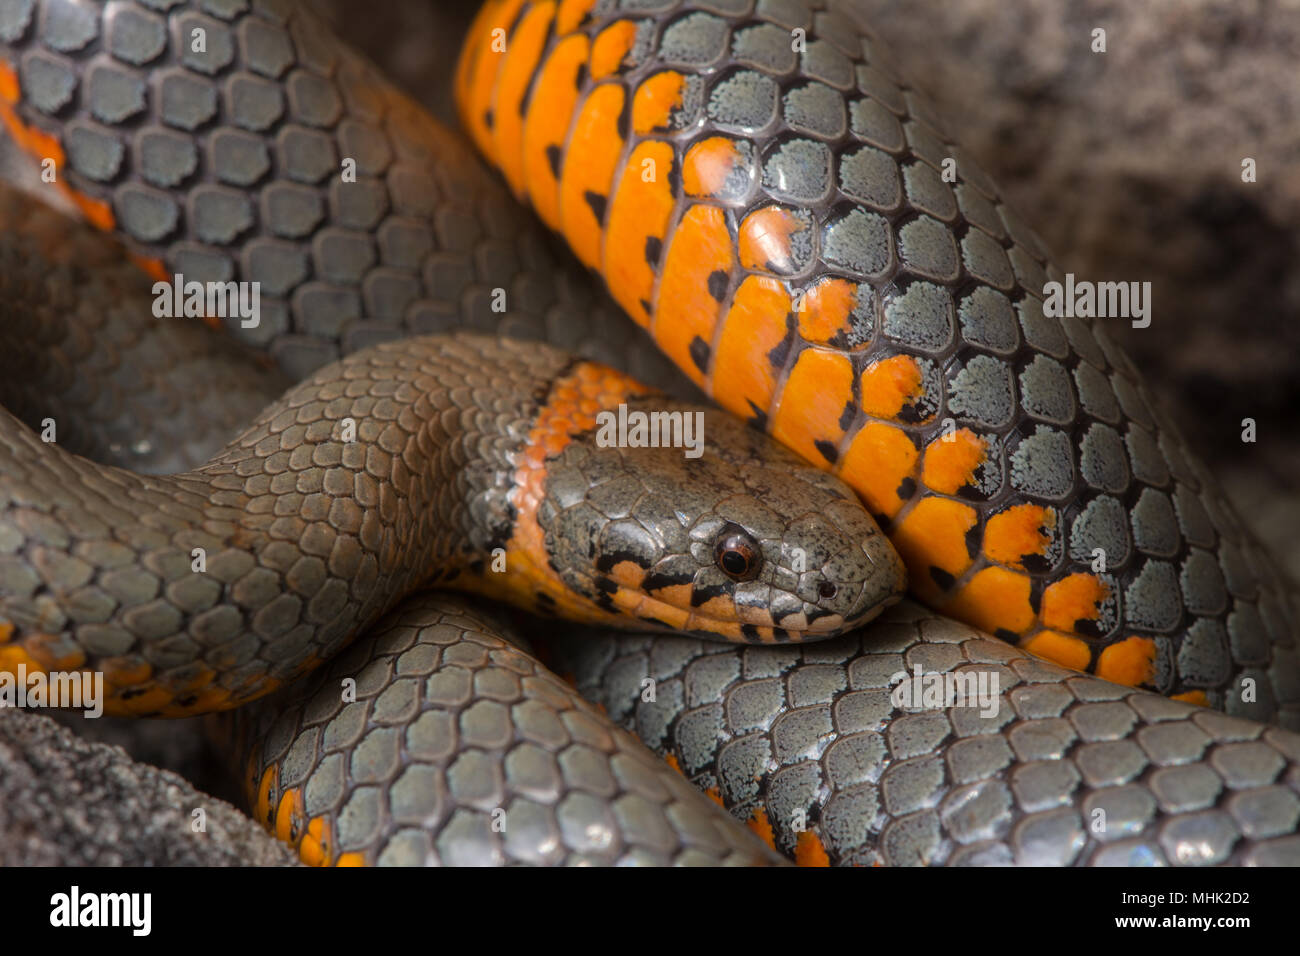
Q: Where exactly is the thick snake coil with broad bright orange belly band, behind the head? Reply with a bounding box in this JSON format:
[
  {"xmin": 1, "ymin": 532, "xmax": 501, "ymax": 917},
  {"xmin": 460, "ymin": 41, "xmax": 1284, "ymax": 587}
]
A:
[{"xmin": 456, "ymin": 0, "xmax": 1300, "ymax": 728}]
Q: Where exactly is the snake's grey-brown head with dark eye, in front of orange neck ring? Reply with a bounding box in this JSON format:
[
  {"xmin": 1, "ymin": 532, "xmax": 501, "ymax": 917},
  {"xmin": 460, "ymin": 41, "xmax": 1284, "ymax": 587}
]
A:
[{"xmin": 537, "ymin": 395, "xmax": 906, "ymax": 643}]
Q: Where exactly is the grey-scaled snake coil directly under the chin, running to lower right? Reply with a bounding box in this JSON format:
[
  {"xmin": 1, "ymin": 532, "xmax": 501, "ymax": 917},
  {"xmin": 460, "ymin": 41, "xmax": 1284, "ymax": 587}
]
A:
[{"xmin": 550, "ymin": 601, "xmax": 1300, "ymax": 866}]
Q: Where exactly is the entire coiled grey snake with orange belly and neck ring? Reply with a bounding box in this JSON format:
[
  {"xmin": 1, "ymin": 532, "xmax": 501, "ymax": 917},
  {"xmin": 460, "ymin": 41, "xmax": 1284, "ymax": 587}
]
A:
[{"xmin": 0, "ymin": 0, "xmax": 1300, "ymax": 865}]
